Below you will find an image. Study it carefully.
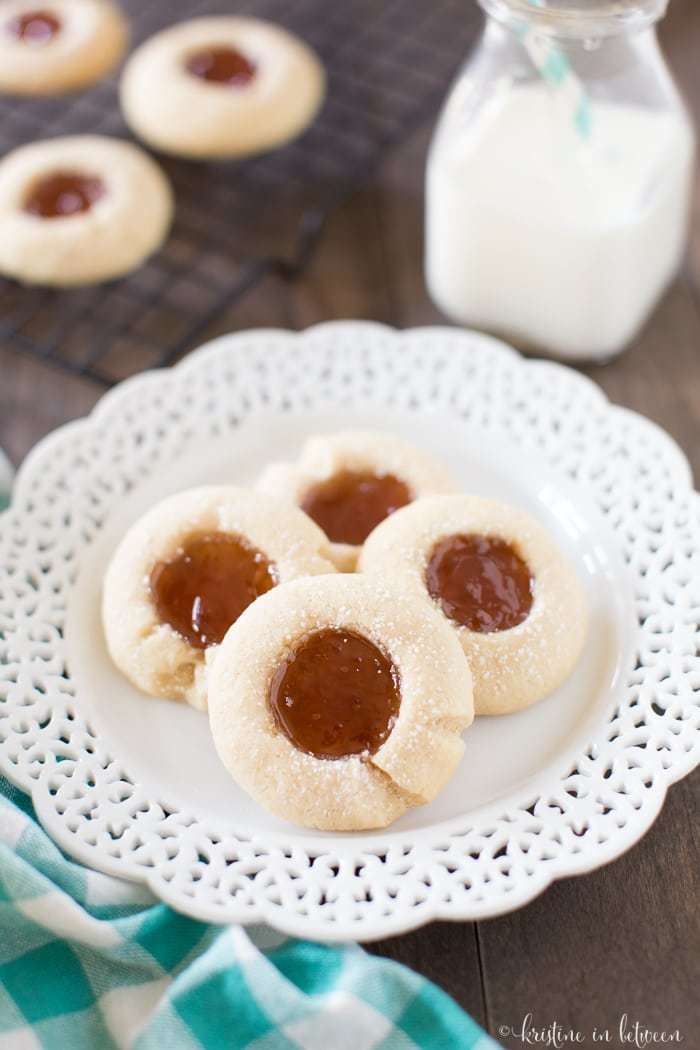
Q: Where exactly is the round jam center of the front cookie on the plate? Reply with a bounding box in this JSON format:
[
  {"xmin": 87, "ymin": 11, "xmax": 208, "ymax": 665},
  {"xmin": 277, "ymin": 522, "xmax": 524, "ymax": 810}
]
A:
[{"xmin": 270, "ymin": 628, "xmax": 401, "ymax": 758}]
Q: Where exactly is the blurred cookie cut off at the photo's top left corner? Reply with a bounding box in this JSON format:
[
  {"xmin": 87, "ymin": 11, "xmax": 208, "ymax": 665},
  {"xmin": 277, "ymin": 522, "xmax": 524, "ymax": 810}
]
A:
[{"xmin": 0, "ymin": 0, "xmax": 129, "ymax": 96}]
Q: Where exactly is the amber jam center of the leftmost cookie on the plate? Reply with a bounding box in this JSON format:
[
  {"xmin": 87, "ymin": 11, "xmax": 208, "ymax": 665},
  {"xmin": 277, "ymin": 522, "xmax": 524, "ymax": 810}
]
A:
[{"xmin": 150, "ymin": 532, "xmax": 277, "ymax": 649}]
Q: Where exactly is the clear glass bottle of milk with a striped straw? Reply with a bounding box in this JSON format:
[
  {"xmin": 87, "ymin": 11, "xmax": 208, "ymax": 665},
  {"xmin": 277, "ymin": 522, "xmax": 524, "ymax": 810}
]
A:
[{"xmin": 426, "ymin": 0, "xmax": 695, "ymax": 360}]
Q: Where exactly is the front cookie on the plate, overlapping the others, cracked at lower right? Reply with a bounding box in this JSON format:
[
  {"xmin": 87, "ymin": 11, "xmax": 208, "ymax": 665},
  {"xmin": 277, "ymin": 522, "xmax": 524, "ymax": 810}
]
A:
[{"xmin": 209, "ymin": 574, "xmax": 473, "ymax": 831}]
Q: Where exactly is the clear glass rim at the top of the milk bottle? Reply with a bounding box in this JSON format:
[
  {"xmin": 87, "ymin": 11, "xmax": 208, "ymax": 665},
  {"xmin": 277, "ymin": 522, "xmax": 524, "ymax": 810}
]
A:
[{"xmin": 479, "ymin": 0, "xmax": 669, "ymax": 39}]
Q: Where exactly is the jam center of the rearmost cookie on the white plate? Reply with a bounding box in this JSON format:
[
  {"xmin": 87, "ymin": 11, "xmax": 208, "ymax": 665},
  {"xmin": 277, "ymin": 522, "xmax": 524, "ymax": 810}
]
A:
[{"xmin": 301, "ymin": 470, "xmax": 412, "ymax": 544}]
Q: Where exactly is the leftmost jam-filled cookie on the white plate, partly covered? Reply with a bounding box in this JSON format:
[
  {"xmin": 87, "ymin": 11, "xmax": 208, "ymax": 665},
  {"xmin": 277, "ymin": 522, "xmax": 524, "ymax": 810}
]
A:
[{"xmin": 102, "ymin": 485, "xmax": 333, "ymax": 709}]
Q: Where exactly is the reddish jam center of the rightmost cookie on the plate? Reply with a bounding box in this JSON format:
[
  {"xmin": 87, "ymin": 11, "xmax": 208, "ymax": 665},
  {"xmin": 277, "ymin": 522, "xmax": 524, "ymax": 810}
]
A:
[{"xmin": 426, "ymin": 536, "xmax": 533, "ymax": 634}]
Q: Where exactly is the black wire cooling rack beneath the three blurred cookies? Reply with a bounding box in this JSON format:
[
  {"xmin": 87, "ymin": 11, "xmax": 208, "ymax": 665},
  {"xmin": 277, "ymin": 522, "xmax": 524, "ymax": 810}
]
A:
[{"xmin": 0, "ymin": 0, "xmax": 479, "ymax": 385}]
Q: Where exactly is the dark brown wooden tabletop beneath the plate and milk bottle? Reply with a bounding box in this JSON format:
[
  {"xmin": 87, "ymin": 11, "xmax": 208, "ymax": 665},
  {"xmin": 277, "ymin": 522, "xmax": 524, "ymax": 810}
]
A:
[{"xmin": 0, "ymin": 0, "xmax": 700, "ymax": 1050}]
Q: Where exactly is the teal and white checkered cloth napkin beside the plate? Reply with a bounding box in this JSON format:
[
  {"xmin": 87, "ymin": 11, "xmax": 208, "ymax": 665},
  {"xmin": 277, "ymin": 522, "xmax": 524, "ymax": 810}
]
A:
[{"xmin": 0, "ymin": 453, "xmax": 497, "ymax": 1050}]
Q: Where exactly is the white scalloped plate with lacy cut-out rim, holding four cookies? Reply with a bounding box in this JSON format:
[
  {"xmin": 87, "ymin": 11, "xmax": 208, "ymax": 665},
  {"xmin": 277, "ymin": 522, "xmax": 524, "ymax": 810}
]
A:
[{"xmin": 0, "ymin": 321, "xmax": 700, "ymax": 940}]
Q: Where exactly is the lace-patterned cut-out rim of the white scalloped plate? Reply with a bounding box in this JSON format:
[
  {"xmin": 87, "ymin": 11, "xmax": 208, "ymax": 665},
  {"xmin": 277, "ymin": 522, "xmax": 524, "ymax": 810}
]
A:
[{"xmin": 0, "ymin": 322, "xmax": 700, "ymax": 940}]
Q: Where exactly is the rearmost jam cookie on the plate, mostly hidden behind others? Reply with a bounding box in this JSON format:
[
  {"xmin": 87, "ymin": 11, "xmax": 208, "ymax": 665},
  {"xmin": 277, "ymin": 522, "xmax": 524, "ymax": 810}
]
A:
[{"xmin": 257, "ymin": 431, "xmax": 458, "ymax": 572}]
